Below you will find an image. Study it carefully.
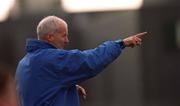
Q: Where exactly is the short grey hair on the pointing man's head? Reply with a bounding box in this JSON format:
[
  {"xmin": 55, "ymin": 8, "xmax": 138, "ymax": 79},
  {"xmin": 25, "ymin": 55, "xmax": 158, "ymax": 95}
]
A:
[{"xmin": 37, "ymin": 16, "xmax": 65, "ymax": 39}]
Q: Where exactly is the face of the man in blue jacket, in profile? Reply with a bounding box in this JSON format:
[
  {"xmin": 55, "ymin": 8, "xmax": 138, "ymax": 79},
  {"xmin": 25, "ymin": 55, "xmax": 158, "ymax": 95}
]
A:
[{"xmin": 50, "ymin": 25, "xmax": 69, "ymax": 49}]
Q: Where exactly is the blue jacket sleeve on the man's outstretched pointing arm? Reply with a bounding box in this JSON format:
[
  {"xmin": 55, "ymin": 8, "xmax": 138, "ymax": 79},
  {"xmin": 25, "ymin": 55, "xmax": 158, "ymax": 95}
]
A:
[{"xmin": 53, "ymin": 41, "xmax": 125, "ymax": 85}]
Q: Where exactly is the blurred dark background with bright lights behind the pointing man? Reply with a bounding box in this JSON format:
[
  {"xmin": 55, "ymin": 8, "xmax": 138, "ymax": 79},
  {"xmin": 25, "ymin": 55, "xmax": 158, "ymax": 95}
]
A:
[{"xmin": 0, "ymin": 0, "xmax": 180, "ymax": 106}]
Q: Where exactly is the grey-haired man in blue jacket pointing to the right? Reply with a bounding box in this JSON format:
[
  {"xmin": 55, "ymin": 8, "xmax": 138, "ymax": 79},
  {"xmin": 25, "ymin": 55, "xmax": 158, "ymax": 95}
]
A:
[{"xmin": 16, "ymin": 16, "xmax": 146, "ymax": 106}]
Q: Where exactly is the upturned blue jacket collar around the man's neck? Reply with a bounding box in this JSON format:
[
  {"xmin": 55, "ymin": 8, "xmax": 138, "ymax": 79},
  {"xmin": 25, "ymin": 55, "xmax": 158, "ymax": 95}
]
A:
[{"xmin": 26, "ymin": 39, "xmax": 56, "ymax": 52}]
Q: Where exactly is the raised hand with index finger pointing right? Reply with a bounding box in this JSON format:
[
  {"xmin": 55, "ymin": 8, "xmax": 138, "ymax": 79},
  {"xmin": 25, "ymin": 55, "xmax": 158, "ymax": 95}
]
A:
[{"xmin": 123, "ymin": 32, "xmax": 147, "ymax": 47}]
